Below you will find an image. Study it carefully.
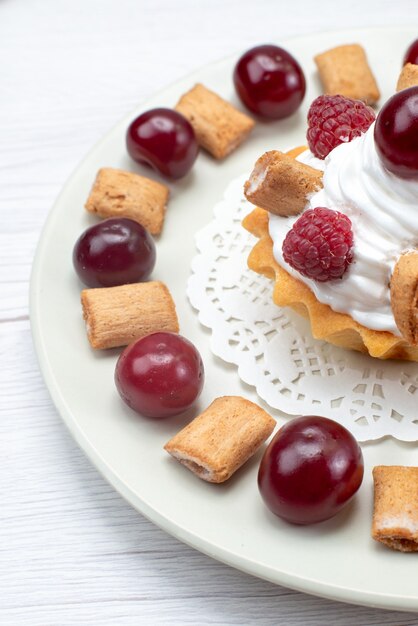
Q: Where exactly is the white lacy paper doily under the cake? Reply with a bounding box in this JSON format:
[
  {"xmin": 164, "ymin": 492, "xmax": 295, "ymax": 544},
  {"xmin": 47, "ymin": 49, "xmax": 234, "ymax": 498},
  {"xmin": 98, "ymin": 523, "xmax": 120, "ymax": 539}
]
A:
[{"xmin": 187, "ymin": 177, "xmax": 418, "ymax": 441}]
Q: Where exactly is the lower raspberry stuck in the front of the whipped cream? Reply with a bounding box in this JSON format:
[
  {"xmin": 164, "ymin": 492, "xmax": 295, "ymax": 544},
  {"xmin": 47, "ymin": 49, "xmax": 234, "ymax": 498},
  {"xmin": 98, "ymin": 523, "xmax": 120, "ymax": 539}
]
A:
[{"xmin": 282, "ymin": 207, "xmax": 353, "ymax": 282}]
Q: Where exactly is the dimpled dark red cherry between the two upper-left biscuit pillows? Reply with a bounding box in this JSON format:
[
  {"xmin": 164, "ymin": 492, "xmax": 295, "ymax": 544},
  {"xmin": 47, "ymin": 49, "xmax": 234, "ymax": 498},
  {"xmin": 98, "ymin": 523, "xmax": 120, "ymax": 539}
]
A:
[{"xmin": 126, "ymin": 108, "xmax": 199, "ymax": 179}]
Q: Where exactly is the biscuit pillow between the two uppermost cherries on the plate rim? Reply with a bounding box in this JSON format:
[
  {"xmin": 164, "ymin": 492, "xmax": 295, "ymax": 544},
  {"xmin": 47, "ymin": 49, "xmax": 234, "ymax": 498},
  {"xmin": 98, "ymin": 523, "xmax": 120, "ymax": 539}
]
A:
[{"xmin": 175, "ymin": 84, "xmax": 255, "ymax": 159}]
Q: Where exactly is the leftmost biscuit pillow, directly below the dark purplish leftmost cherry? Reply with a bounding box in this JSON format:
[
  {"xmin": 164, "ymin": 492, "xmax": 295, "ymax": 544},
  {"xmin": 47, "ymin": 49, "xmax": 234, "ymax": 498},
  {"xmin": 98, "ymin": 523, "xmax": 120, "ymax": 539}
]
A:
[{"xmin": 81, "ymin": 281, "xmax": 179, "ymax": 350}]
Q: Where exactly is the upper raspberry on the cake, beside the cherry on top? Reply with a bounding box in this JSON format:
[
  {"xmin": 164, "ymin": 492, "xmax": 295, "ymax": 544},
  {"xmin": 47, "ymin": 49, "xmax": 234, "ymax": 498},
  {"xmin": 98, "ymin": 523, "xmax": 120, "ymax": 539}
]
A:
[{"xmin": 306, "ymin": 96, "xmax": 376, "ymax": 159}]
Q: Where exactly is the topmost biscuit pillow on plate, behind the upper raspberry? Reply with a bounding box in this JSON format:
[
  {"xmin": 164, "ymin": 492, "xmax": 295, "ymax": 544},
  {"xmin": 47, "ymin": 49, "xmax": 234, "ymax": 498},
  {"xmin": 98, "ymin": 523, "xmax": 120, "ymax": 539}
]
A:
[{"xmin": 314, "ymin": 44, "xmax": 380, "ymax": 104}]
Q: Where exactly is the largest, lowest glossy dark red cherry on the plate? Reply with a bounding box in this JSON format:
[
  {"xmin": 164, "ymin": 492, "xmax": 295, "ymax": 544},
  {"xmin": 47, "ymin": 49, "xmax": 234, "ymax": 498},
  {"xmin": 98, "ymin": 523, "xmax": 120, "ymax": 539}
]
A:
[{"xmin": 258, "ymin": 415, "xmax": 364, "ymax": 524}]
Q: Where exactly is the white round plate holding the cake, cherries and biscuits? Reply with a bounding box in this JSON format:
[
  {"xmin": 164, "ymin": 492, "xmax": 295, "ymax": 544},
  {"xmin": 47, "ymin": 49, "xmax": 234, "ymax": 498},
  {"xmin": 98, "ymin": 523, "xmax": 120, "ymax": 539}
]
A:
[{"xmin": 31, "ymin": 28, "xmax": 418, "ymax": 610}]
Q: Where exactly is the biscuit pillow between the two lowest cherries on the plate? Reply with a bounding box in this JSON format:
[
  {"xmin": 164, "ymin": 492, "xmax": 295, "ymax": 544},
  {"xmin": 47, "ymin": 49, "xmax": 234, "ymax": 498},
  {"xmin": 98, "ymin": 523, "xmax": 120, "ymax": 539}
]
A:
[{"xmin": 164, "ymin": 396, "xmax": 276, "ymax": 483}]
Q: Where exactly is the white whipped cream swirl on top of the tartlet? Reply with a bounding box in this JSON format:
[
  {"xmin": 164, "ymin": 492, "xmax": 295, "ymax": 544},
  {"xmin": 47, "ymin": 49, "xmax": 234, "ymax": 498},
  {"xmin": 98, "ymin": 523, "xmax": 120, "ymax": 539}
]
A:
[{"xmin": 269, "ymin": 124, "xmax": 418, "ymax": 335}]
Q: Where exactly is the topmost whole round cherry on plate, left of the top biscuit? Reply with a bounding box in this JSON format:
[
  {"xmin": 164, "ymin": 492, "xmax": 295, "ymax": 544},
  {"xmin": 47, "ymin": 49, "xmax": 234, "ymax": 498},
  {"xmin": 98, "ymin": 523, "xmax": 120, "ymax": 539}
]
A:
[{"xmin": 234, "ymin": 45, "xmax": 306, "ymax": 120}]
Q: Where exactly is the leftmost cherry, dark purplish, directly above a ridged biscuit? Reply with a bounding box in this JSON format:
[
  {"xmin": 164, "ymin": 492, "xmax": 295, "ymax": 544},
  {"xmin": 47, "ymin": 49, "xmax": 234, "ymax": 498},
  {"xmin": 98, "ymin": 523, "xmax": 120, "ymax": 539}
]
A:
[{"xmin": 73, "ymin": 217, "xmax": 156, "ymax": 287}]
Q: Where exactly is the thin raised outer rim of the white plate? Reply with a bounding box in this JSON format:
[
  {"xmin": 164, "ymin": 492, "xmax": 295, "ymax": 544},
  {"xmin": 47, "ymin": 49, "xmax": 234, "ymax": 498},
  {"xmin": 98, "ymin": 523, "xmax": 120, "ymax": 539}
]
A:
[{"xmin": 29, "ymin": 25, "xmax": 418, "ymax": 611}]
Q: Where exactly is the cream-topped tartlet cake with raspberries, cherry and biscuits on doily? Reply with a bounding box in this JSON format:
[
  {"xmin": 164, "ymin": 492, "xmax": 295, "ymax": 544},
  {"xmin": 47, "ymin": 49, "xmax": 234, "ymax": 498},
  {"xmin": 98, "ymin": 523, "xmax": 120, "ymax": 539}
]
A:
[{"xmin": 243, "ymin": 87, "xmax": 418, "ymax": 361}]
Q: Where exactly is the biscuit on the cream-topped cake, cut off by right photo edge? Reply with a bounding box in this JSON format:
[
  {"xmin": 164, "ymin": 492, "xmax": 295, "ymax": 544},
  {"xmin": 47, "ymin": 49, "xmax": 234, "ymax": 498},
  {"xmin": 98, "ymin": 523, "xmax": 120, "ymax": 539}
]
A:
[{"xmin": 390, "ymin": 250, "xmax": 418, "ymax": 346}]
